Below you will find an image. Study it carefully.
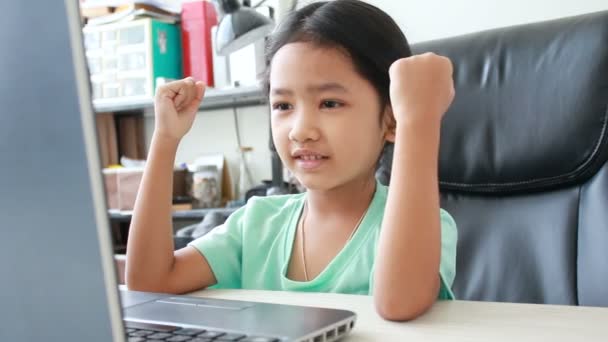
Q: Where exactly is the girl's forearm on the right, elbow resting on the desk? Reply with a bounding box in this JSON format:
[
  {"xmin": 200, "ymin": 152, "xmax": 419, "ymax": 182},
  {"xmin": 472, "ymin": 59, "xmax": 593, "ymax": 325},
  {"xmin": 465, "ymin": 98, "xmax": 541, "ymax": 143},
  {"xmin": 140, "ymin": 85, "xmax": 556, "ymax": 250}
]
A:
[{"xmin": 374, "ymin": 118, "xmax": 441, "ymax": 320}]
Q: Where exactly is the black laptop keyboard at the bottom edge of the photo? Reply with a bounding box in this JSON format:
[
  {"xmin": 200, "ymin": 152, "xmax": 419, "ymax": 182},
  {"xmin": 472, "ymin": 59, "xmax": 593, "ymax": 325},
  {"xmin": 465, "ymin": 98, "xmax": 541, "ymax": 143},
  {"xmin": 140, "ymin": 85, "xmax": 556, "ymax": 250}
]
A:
[{"xmin": 125, "ymin": 321, "xmax": 279, "ymax": 342}]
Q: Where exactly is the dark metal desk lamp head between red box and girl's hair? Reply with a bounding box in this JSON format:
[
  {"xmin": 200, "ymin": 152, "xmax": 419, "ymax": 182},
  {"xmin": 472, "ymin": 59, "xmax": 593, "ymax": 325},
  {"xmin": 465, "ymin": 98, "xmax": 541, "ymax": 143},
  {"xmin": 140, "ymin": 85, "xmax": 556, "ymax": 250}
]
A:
[{"xmin": 213, "ymin": 0, "xmax": 274, "ymax": 56}]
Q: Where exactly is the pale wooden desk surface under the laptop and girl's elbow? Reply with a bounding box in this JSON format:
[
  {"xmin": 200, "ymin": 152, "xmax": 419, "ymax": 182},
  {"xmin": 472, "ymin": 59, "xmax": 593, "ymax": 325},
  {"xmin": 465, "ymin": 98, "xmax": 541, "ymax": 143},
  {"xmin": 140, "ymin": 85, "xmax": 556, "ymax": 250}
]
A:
[{"xmin": 185, "ymin": 290, "xmax": 608, "ymax": 342}]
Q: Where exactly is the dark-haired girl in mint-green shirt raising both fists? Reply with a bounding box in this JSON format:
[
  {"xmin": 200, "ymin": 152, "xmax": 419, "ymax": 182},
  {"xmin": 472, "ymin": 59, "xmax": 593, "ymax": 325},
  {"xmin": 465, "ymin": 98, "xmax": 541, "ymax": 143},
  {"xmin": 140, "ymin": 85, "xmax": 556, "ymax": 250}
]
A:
[{"xmin": 126, "ymin": 0, "xmax": 456, "ymax": 320}]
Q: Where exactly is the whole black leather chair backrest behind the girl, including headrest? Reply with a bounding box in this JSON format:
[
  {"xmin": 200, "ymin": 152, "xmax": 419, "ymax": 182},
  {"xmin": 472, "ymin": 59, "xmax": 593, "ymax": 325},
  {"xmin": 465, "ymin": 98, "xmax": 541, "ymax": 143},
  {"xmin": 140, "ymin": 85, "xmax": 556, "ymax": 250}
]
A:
[{"xmin": 380, "ymin": 11, "xmax": 608, "ymax": 306}]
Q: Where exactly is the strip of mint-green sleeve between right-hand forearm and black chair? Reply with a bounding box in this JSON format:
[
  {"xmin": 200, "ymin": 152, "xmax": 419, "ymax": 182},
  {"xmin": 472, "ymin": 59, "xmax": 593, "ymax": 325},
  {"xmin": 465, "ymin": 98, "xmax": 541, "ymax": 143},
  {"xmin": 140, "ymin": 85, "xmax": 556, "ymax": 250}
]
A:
[{"xmin": 438, "ymin": 209, "xmax": 458, "ymax": 299}]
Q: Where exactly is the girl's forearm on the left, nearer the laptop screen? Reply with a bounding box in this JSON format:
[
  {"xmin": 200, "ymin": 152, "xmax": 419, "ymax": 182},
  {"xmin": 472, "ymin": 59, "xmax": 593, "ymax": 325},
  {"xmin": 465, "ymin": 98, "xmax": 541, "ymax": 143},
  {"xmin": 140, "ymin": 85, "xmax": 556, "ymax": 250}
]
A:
[{"xmin": 126, "ymin": 135, "xmax": 178, "ymax": 290}]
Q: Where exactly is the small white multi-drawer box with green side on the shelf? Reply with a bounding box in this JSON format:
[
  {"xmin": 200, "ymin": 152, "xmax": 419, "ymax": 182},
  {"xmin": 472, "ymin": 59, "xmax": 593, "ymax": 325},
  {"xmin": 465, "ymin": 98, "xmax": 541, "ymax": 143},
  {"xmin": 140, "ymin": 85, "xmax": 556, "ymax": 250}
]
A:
[{"xmin": 83, "ymin": 18, "xmax": 182, "ymax": 105}]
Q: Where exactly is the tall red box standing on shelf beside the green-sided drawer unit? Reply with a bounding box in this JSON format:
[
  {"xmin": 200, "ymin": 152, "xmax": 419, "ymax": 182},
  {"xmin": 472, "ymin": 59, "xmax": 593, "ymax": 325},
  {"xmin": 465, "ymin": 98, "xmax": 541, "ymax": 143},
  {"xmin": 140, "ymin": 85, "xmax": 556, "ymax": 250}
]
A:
[{"xmin": 182, "ymin": 0, "xmax": 217, "ymax": 87}]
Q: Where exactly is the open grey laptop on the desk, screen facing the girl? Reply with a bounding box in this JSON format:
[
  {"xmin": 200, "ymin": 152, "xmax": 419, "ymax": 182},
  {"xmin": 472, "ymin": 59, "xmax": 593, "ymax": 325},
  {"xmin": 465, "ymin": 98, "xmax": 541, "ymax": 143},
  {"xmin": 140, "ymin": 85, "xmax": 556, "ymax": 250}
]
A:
[{"xmin": 0, "ymin": 0, "xmax": 356, "ymax": 342}]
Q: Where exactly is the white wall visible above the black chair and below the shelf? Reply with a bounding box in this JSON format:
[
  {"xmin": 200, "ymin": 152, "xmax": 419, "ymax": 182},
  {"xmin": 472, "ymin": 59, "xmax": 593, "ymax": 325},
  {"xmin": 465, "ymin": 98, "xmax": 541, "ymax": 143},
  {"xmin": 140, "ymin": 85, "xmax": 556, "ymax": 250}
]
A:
[{"xmin": 147, "ymin": 0, "xmax": 608, "ymax": 187}]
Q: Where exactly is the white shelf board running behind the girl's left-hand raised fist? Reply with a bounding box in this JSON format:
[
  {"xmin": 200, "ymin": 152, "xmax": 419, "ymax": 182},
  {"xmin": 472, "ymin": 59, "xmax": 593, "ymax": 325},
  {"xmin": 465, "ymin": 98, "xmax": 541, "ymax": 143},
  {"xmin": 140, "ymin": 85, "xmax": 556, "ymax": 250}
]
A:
[{"xmin": 93, "ymin": 86, "xmax": 268, "ymax": 113}]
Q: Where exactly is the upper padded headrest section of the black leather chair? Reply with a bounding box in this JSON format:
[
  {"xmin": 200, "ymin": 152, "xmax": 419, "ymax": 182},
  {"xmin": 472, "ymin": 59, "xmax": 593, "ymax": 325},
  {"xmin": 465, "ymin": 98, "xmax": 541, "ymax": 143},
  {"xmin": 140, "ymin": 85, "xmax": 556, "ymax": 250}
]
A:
[{"xmin": 412, "ymin": 11, "xmax": 608, "ymax": 193}]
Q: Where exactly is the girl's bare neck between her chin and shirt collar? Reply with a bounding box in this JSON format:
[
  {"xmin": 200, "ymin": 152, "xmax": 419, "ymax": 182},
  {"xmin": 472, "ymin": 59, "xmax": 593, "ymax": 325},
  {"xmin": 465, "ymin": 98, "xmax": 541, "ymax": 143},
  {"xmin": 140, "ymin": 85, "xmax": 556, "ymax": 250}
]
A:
[{"xmin": 306, "ymin": 176, "xmax": 376, "ymax": 218}]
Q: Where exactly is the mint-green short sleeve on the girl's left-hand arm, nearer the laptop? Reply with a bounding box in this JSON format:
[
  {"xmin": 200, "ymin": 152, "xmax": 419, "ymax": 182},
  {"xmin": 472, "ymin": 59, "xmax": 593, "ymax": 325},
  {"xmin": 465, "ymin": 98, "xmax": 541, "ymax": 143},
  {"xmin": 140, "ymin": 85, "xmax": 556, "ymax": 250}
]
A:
[{"xmin": 188, "ymin": 207, "xmax": 245, "ymax": 289}]
